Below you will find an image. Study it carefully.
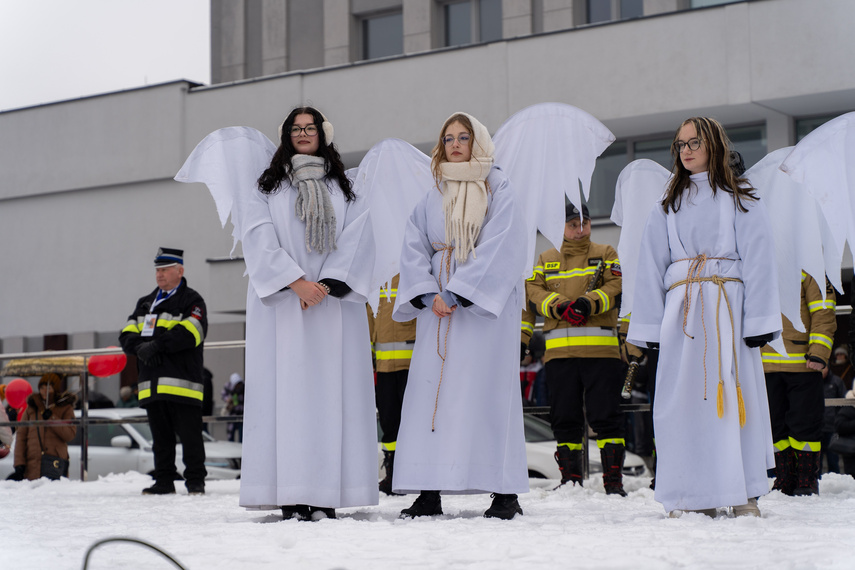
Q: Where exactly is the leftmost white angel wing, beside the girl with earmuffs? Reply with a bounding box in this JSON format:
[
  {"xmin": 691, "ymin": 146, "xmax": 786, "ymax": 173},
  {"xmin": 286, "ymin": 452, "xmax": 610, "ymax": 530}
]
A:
[{"xmin": 175, "ymin": 127, "xmax": 276, "ymax": 251}]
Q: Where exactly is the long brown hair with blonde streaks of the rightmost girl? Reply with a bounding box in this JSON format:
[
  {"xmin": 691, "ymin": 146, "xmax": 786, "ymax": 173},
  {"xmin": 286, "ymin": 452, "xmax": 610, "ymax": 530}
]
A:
[{"xmin": 662, "ymin": 117, "xmax": 758, "ymax": 212}]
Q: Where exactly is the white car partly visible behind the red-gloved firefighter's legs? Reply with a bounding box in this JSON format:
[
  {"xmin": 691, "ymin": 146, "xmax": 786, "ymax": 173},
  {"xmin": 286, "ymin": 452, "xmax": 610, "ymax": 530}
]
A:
[{"xmin": 377, "ymin": 414, "xmax": 650, "ymax": 480}]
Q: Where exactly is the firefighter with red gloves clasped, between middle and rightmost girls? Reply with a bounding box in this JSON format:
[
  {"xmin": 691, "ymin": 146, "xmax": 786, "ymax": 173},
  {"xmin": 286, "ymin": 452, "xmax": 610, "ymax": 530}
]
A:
[{"xmin": 523, "ymin": 204, "xmax": 626, "ymax": 496}]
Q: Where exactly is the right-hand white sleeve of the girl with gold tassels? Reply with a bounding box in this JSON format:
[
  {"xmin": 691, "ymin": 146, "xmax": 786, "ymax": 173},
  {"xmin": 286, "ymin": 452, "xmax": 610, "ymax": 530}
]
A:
[{"xmin": 735, "ymin": 200, "xmax": 782, "ymax": 338}]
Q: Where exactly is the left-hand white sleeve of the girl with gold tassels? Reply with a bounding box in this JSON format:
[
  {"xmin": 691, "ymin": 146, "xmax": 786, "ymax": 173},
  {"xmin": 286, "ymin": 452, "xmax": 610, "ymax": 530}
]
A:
[{"xmin": 626, "ymin": 205, "xmax": 671, "ymax": 346}]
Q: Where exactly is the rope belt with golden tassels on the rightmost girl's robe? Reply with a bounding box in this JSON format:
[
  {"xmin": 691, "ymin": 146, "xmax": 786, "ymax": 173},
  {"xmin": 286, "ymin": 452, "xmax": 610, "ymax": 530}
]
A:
[{"xmin": 668, "ymin": 253, "xmax": 745, "ymax": 428}]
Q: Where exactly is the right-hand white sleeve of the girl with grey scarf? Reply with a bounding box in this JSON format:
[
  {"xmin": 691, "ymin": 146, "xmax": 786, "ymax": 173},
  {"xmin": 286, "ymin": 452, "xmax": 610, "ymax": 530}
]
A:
[{"xmin": 318, "ymin": 190, "xmax": 374, "ymax": 304}]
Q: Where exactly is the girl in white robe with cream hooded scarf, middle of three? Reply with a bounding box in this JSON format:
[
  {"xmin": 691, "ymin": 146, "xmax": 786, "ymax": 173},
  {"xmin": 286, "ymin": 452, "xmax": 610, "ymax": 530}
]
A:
[{"xmin": 392, "ymin": 113, "xmax": 528, "ymax": 519}]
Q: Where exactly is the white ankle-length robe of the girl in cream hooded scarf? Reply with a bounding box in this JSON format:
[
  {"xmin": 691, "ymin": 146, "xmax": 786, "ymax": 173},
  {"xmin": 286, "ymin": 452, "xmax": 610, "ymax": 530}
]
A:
[{"xmin": 392, "ymin": 167, "xmax": 529, "ymax": 493}]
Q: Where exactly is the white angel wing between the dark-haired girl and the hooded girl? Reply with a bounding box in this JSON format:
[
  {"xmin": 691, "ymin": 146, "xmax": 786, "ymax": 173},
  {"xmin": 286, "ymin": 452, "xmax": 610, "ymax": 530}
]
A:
[{"xmin": 354, "ymin": 139, "xmax": 435, "ymax": 314}]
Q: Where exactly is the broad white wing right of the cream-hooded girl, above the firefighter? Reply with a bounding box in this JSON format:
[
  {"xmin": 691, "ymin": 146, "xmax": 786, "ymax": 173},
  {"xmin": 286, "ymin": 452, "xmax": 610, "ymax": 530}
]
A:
[{"xmin": 493, "ymin": 103, "xmax": 615, "ymax": 268}]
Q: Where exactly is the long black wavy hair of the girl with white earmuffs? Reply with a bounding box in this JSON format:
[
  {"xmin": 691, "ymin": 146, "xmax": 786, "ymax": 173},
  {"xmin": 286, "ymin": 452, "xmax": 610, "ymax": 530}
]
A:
[{"xmin": 258, "ymin": 107, "xmax": 356, "ymax": 202}]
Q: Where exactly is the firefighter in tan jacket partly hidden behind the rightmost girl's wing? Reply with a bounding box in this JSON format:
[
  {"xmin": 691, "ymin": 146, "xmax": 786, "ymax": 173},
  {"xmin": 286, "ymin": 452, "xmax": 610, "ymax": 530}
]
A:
[{"xmin": 761, "ymin": 272, "xmax": 837, "ymax": 495}]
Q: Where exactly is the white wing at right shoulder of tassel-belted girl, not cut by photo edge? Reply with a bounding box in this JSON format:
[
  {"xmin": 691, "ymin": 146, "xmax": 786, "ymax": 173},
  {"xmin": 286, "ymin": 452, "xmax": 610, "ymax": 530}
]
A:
[{"xmin": 745, "ymin": 147, "xmax": 839, "ymax": 354}]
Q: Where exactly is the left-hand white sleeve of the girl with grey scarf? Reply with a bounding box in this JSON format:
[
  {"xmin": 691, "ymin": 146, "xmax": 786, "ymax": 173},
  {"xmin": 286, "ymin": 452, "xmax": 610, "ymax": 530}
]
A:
[{"xmin": 237, "ymin": 186, "xmax": 306, "ymax": 306}]
